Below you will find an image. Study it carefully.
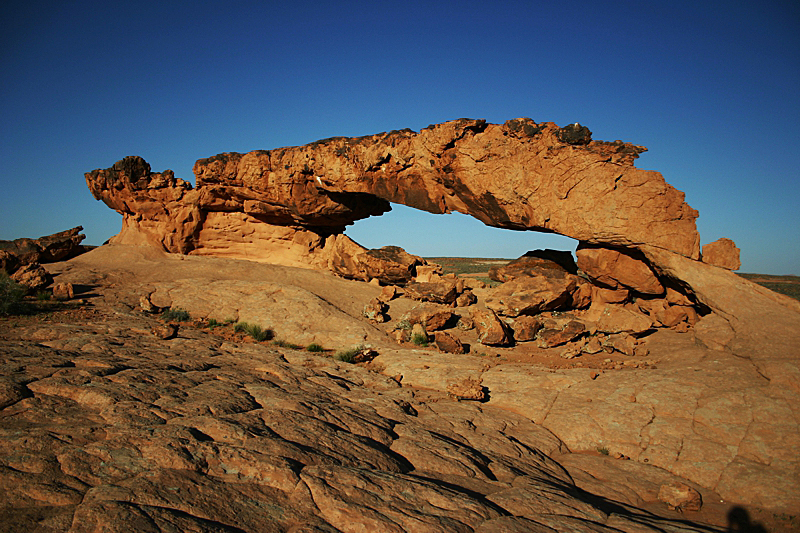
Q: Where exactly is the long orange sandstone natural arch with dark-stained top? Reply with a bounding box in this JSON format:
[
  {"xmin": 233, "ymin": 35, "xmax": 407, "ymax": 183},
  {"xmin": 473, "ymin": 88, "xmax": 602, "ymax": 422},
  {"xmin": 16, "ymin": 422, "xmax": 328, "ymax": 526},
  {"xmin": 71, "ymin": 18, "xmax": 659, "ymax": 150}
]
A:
[{"xmin": 86, "ymin": 119, "xmax": 699, "ymax": 279}]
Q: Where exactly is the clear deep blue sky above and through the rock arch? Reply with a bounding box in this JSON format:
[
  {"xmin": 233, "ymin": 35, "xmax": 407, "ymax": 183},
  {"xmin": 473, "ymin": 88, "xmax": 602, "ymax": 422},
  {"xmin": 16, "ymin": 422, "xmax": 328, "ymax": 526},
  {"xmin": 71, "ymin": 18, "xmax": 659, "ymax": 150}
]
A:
[{"xmin": 0, "ymin": 0, "xmax": 800, "ymax": 274}]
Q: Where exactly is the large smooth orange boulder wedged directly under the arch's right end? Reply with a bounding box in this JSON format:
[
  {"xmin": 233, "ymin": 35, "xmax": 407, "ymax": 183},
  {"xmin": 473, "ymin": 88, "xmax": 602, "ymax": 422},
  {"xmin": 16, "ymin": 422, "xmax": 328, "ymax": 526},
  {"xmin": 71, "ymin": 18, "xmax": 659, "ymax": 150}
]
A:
[{"xmin": 575, "ymin": 243, "xmax": 664, "ymax": 295}]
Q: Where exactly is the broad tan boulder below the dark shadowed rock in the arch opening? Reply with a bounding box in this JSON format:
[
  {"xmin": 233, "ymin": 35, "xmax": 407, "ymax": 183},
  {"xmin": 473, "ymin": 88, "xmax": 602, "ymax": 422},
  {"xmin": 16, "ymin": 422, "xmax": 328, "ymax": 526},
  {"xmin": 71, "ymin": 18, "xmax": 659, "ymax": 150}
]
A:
[{"xmin": 486, "ymin": 270, "xmax": 581, "ymax": 317}]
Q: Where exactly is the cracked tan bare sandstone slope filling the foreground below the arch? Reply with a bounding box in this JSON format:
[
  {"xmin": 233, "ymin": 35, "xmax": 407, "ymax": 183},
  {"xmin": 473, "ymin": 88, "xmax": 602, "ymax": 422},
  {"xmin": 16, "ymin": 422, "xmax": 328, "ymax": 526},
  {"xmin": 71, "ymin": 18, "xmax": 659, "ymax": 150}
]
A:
[{"xmin": 0, "ymin": 245, "xmax": 800, "ymax": 532}]
